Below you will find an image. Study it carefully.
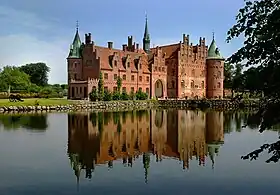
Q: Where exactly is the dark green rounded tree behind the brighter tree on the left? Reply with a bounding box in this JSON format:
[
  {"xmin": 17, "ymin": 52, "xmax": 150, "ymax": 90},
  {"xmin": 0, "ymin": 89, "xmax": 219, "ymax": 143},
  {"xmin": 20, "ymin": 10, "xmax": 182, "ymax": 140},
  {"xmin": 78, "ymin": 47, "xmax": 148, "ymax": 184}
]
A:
[{"xmin": 20, "ymin": 62, "xmax": 50, "ymax": 86}]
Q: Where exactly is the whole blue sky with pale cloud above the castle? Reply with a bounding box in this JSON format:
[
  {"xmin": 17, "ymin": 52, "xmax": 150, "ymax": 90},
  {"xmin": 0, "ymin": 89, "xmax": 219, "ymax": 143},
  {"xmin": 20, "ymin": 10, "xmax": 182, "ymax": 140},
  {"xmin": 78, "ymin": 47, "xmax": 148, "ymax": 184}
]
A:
[{"xmin": 0, "ymin": 0, "xmax": 244, "ymax": 83}]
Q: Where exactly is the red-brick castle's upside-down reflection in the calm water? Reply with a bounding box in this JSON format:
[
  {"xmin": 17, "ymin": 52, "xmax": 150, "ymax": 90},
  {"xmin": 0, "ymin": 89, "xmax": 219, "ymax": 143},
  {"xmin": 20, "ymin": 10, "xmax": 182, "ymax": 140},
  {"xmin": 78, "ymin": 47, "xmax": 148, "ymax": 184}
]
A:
[{"xmin": 68, "ymin": 110, "xmax": 224, "ymax": 183}]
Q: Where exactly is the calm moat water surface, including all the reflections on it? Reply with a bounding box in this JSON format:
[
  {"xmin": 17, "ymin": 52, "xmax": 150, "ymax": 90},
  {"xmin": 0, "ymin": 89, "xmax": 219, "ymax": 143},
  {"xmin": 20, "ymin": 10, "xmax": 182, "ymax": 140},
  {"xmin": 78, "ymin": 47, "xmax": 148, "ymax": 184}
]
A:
[{"xmin": 0, "ymin": 110, "xmax": 280, "ymax": 195}]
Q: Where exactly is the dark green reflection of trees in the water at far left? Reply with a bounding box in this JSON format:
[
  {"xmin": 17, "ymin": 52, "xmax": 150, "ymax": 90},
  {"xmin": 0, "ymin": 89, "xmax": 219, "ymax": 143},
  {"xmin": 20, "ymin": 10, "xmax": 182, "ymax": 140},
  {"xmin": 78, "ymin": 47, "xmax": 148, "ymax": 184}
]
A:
[{"xmin": 0, "ymin": 113, "xmax": 48, "ymax": 132}]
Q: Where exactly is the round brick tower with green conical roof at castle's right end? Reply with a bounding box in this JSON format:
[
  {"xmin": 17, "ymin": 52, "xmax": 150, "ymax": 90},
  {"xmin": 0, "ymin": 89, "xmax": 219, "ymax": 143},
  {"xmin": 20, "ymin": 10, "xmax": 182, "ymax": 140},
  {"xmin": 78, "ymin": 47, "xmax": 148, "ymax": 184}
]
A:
[{"xmin": 206, "ymin": 36, "xmax": 225, "ymax": 99}]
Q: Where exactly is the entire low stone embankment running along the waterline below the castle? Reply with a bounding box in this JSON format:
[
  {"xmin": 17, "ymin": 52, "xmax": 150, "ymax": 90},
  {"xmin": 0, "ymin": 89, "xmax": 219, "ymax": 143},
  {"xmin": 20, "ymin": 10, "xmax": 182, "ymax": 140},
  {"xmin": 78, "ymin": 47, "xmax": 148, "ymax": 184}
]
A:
[{"xmin": 0, "ymin": 100, "xmax": 260, "ymax": 113}]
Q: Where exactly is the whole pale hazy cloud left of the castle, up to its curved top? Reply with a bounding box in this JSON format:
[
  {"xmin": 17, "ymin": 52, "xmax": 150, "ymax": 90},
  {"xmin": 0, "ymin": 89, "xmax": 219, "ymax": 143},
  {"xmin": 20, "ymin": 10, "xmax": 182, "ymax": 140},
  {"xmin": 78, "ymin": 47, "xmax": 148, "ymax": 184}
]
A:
[{"xmin": 0, "ymin": 6, "xmax": 73, "ymax": 83}]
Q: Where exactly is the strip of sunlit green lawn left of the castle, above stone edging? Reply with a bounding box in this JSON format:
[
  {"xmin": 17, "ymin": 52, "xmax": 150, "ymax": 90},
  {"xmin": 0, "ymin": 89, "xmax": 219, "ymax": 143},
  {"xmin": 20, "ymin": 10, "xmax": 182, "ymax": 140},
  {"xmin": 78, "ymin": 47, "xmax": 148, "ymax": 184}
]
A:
[{"xmin": 0, "ymin": 98, "xmax": 75, "ymax": 107}]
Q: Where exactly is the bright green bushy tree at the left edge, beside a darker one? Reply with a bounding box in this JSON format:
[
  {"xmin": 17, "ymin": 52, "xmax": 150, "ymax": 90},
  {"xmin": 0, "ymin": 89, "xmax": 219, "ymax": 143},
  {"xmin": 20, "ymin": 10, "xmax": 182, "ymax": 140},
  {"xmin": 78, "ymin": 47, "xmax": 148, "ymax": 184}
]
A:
[{"xmin": 0, "ymin": 66, "xmax": 31, "ymax": 91}]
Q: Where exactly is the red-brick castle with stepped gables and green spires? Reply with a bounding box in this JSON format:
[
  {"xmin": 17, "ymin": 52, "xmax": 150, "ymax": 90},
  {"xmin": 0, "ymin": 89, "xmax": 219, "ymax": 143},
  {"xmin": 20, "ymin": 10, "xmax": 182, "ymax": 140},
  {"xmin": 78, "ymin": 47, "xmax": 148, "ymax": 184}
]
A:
[{"xmin": 67, "ymin": 17, "xmax": 224, "ymax": 99}]
